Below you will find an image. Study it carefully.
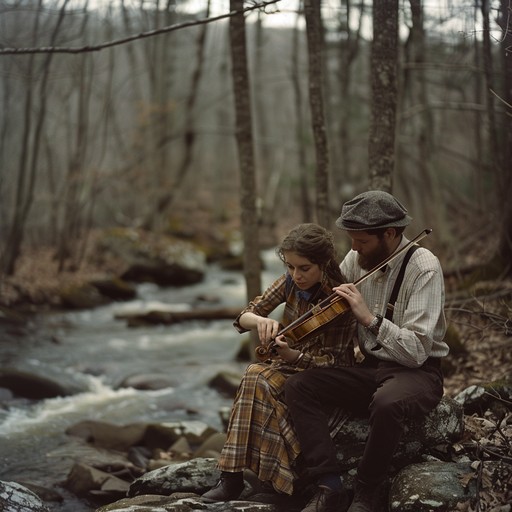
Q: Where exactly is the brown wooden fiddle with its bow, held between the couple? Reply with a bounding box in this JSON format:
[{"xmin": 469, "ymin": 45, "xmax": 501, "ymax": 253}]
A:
[{"xmin": 255, "ymin": 229, "xmax": 432, "ymax": 362}]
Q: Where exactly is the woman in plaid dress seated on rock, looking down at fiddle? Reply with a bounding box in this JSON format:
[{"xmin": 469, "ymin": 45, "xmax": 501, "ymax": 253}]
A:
[{"xmin": 203, "ymin": 224, "xmax": 356, "ymax": 502}]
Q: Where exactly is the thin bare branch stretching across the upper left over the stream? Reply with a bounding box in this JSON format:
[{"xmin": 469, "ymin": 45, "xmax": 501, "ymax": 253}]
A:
[{"xmin": 0, "ymin": 0, "xmax": 279, "ymax": 55}]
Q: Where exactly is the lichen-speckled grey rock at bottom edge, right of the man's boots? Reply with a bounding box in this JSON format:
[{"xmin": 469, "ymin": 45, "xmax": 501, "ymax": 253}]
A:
[{"xmin": 389, "ymin": 462, "xmax": 476, "ymax": 512}]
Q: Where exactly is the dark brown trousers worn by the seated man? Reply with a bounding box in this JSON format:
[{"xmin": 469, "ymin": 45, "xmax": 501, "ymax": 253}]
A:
[{"xmin": 285, "ymin": 359, "xmax": 443, "ymax": 484}]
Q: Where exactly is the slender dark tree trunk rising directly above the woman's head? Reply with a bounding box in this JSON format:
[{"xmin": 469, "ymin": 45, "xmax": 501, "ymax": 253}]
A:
[{"xmin": 304, "ymin": 0, "xmax": 332, "ymax": 228}]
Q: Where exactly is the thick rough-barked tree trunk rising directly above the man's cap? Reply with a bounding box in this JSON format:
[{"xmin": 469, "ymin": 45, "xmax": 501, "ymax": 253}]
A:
[{"xmin": 368, "ymin": 0, "xmax": 398, "ymax": 192}]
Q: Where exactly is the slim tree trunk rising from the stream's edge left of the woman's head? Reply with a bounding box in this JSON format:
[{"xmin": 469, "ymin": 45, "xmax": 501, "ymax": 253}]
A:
[{"xmin": 229, "ymin": 0, "xmax": 261, "ymax": 348}]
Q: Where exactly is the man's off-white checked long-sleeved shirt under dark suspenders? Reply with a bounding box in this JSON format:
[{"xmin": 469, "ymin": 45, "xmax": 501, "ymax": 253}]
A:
[{"xmin": 340, "ymin": 236, "xmax": 449, "ymax": 368}]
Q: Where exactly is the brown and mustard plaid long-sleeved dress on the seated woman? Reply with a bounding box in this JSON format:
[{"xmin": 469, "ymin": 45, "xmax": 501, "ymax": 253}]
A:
[{"xmin": 219, "ymin": 274, "xmax": 356, "ymax": 494}]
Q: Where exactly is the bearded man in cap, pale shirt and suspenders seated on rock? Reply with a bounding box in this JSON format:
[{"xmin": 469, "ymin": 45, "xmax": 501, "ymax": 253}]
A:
[{"xmin": 285, "ymin": 191, "xmax": 448, "ymax": 512}]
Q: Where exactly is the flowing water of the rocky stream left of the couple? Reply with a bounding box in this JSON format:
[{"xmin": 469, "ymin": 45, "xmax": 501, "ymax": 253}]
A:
[{"xmin": 0, "ymin": 252, "xmax": 282, "ymax": 512}]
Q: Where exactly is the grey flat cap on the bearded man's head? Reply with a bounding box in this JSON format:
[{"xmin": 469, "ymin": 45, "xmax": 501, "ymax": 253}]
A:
[{"xmin": 336, "ymin": 190, "xmax": 412, "ymax": 231}]
